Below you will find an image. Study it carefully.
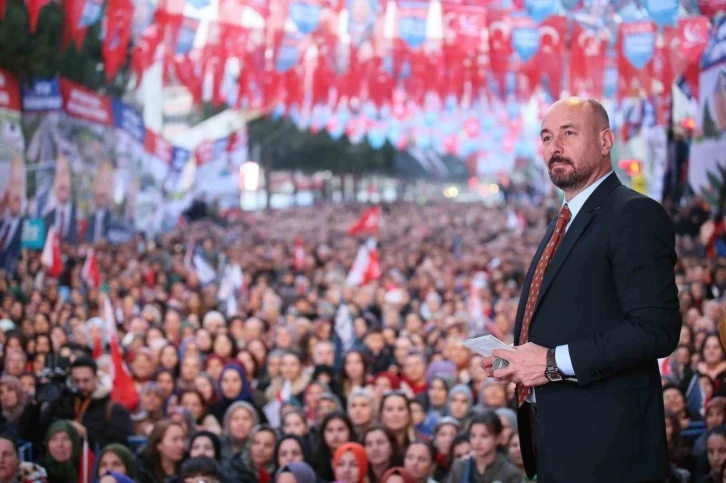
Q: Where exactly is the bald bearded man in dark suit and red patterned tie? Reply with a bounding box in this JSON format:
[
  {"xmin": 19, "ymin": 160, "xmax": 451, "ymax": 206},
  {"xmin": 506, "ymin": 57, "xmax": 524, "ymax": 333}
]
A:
[{"xmin": 482, "ymin": 98, "xmax": 681, "ymax": 483}]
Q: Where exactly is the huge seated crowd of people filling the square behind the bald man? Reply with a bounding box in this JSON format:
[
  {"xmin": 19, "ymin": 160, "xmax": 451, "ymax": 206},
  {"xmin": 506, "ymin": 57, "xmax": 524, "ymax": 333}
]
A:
[{"xmin": 0, "ymin": 195, "xmax": 726, "ymax": 483}]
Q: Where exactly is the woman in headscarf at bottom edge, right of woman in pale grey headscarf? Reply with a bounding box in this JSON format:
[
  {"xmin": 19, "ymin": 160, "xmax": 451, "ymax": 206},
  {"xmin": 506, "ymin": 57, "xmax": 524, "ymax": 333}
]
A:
[{"xmin": 223, "ymin": 425, "xmax": 277, "ymax": 483}]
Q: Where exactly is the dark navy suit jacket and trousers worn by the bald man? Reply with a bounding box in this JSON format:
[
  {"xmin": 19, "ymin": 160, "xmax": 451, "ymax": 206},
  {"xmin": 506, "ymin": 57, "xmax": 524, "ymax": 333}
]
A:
[{"xmin": 515, "ymin": 174, "xmax": 681, "ymax": 483}]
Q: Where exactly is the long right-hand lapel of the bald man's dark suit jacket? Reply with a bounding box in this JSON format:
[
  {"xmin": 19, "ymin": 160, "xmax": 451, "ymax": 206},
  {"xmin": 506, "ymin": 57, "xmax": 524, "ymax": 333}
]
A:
[{"xmin": 534, "ymin": 173, "xmax": 620, "ymax": 312}]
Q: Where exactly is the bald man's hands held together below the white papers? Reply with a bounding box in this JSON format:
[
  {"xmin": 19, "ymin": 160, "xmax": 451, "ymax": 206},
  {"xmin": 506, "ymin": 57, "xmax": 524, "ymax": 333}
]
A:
[{"xmin": 492, "ymin": 342, "xmax": 549, "ymax": 387}]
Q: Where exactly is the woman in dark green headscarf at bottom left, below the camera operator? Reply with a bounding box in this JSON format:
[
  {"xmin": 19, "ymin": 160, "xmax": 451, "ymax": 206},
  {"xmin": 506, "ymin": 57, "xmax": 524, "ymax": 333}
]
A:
[{"xmin": 42, "ymin": 420, "xmax": 94, "ymax": 483}]
